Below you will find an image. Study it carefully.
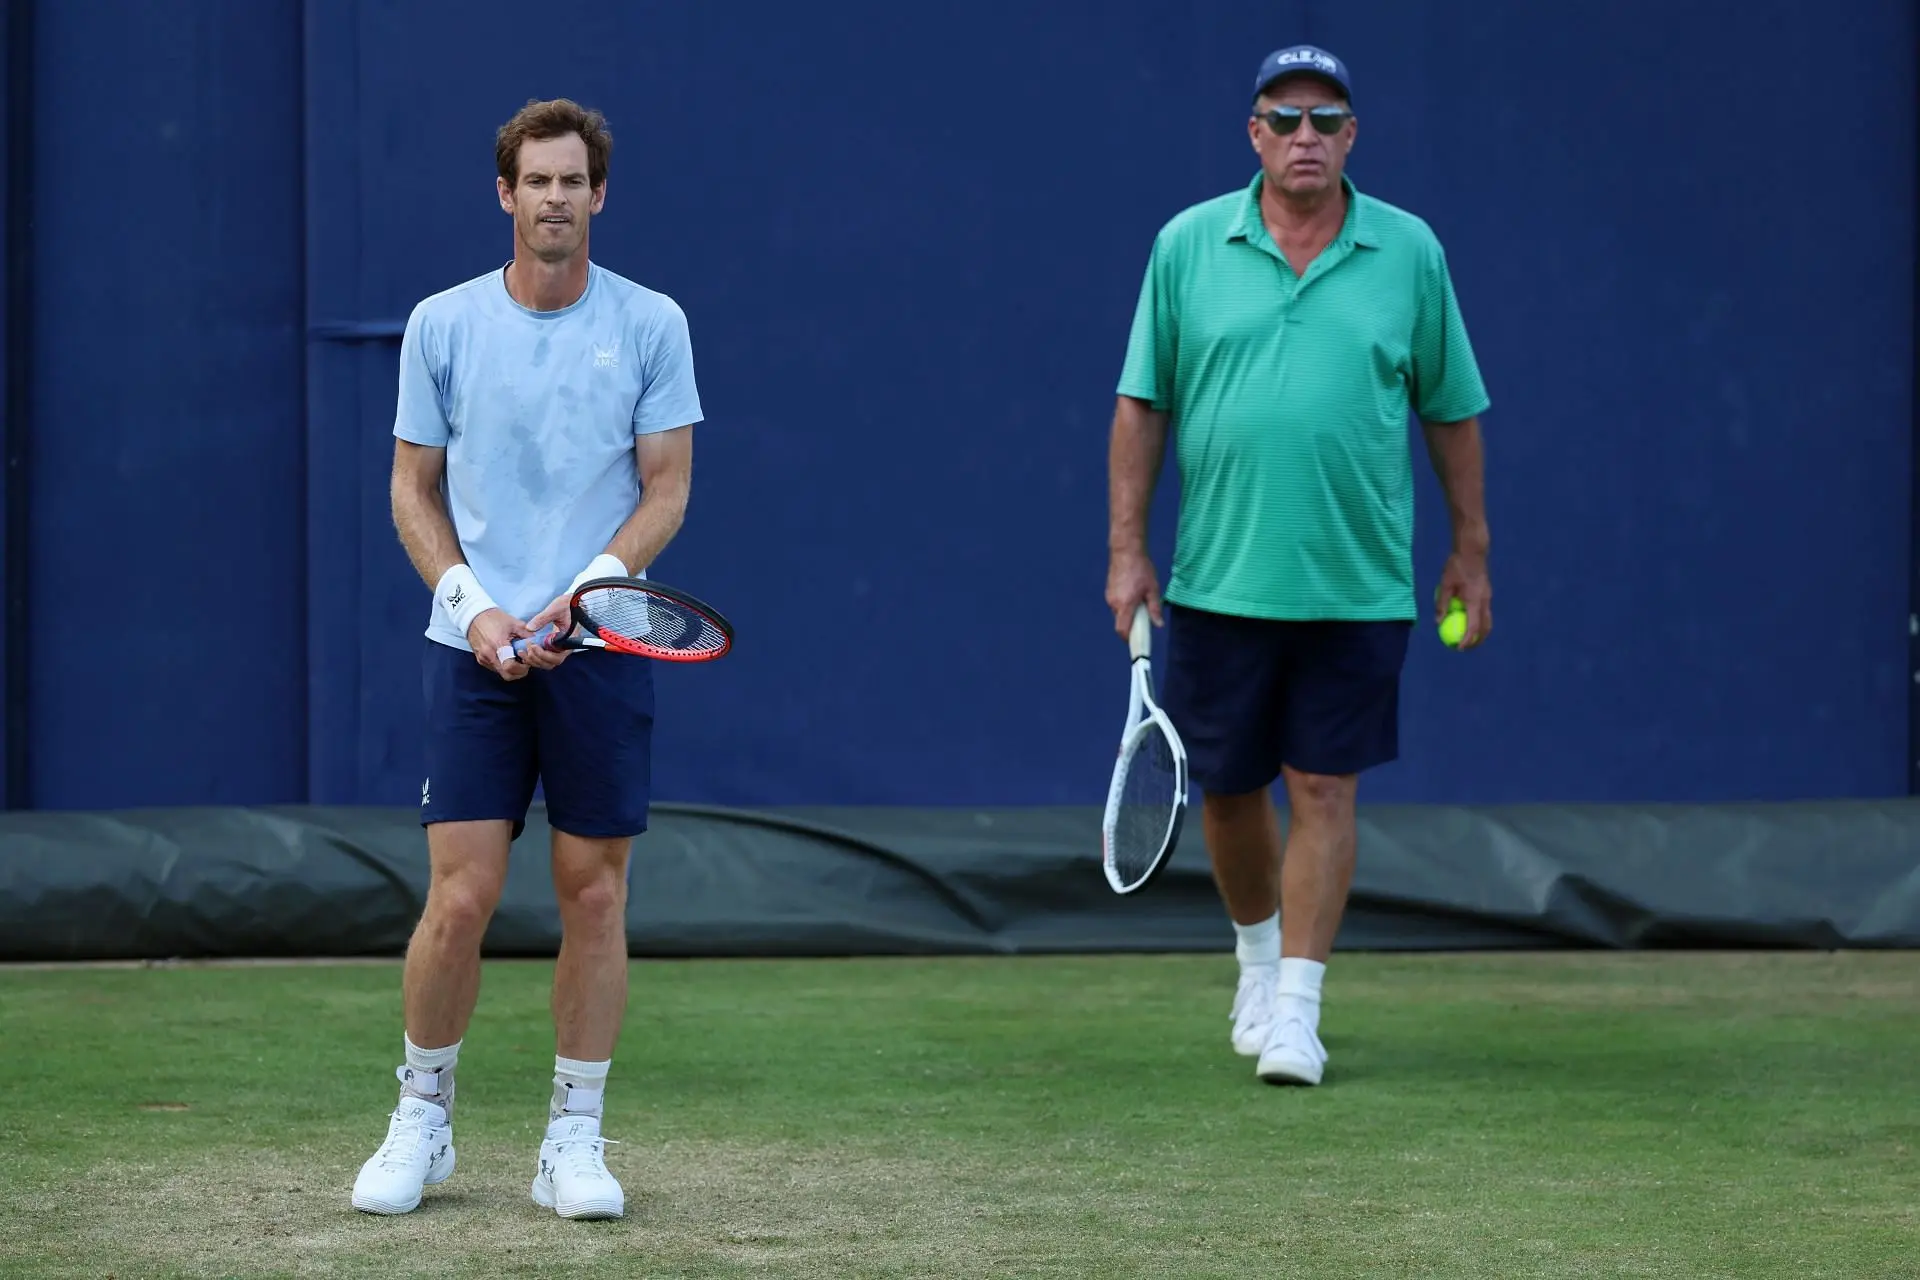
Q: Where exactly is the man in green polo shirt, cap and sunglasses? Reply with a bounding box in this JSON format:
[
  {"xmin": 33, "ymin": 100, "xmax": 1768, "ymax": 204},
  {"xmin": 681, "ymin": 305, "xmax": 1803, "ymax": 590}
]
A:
[{"xmin": 1106, "ymin": 44, "xmax": 1492, "ymax": 1084}]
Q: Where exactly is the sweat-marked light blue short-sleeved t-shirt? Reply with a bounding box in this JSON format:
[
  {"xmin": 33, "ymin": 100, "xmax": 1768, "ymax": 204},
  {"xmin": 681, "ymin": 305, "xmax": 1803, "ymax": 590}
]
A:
[{"xmin": 394, "ymin": 263, "xmax": 701, "ymax": 649}]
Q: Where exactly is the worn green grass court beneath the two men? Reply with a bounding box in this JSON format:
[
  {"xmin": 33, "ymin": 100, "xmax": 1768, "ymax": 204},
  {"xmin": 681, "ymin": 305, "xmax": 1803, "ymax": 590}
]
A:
[{"xmin": 0, "ymin": 954, "xmax": 1920, "ymax": 1280}]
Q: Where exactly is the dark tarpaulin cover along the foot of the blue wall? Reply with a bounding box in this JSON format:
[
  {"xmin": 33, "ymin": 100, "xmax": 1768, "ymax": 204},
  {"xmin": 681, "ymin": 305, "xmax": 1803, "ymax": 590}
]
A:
[{"xmin": 0, "ymin": 800, "xmax": 1920, "ymax": 961}]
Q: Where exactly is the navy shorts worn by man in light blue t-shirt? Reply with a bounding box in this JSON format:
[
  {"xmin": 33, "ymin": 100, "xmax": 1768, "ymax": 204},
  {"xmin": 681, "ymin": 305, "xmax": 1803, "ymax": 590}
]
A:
[{"xmin": 420, "ymin": 639, "xmax": 653, "ymax": 839}]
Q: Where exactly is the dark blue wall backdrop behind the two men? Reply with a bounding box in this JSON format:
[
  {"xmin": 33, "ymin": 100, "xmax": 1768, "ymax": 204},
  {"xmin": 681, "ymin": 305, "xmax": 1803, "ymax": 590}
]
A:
[{"xmin": 6, "ymin": 0, "xmax": 1920, "ymax": 808}]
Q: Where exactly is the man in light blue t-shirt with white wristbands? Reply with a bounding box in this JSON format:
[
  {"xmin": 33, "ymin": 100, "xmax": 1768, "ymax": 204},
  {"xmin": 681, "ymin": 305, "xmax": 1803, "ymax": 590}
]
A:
[{"xmin": 353, "ymin": 98, "xmax": 701, "ymax": 1219}]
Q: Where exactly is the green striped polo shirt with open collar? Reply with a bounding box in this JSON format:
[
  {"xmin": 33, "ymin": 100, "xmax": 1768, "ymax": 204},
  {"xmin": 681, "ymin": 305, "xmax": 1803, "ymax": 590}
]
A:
[{"xmin": 1119, "ymin": 173, "xmax": 1488, "ymax": 620}]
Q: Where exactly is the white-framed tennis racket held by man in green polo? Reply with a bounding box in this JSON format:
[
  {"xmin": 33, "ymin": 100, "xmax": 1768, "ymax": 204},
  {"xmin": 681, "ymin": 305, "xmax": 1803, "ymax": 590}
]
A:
[{"xmin": 1100, "ymin": 604, "xmax": 1187, "ymax": 894}]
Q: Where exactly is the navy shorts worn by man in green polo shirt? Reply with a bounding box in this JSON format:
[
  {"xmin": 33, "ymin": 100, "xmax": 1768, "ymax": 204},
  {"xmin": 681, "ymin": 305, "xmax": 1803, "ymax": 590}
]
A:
[{"xmin": 1160, "ymin": 603, "xmax": 1413, "ymax": 794}]
